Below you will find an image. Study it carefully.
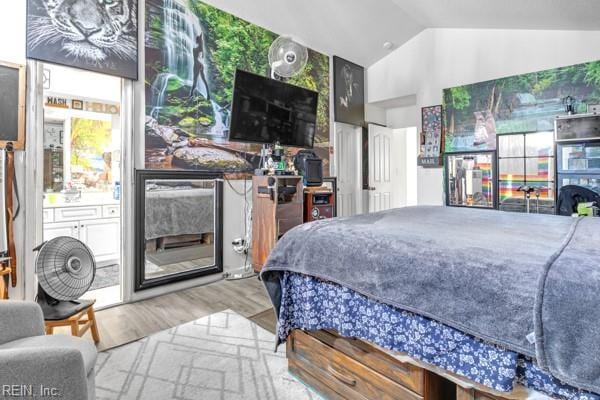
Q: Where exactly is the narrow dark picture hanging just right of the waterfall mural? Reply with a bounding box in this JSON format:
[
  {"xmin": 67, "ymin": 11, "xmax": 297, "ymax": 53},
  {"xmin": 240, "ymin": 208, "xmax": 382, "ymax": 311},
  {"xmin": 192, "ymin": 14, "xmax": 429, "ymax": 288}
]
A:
[{"xmin": 333, "ymin": 56, "xmax": 365, "ymax": 126}]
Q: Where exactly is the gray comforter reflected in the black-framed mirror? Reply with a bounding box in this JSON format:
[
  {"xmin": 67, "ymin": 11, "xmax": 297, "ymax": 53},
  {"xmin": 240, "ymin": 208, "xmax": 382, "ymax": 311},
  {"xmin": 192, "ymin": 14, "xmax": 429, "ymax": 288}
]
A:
[{"xmin": 145, "ymin": 188, "xmax": 215, "ymax": 240}]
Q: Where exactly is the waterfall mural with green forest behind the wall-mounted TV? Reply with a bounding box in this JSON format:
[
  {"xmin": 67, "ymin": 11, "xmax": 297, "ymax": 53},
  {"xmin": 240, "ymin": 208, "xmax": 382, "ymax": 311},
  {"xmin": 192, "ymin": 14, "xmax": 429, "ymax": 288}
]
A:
[{"xmin": 145, "ymin": 0, "xmax": 329, "ymax": 170}]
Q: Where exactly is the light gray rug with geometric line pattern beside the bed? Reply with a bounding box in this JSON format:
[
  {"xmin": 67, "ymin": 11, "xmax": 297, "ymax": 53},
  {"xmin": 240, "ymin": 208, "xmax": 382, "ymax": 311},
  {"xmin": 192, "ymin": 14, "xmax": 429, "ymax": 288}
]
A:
[{"xmin": 96, "ymin": 310, "xmax": 319, "ymax": 400}]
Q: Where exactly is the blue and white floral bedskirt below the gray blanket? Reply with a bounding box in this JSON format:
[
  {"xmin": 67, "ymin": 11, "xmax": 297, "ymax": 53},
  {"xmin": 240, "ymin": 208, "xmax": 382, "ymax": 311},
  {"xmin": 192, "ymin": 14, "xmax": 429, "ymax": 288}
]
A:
[{"xmin": 277, "ymin": 272, "xmax": 600, "ymax": 400}]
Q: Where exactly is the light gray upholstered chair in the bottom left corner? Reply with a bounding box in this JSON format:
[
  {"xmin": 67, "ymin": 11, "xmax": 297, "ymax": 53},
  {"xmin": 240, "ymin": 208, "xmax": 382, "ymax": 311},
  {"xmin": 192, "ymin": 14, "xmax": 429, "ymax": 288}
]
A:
[{"xmin": 0, "ymin": 300, "xmax": 97, "ymax": 400}]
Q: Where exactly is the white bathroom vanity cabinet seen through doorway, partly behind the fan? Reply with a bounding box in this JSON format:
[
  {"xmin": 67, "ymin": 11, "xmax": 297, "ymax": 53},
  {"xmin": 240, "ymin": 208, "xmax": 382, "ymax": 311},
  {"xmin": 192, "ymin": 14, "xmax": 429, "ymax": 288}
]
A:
[{"xmin": 44, "ymin": 205, "xmax": 121, "ymax": 266}]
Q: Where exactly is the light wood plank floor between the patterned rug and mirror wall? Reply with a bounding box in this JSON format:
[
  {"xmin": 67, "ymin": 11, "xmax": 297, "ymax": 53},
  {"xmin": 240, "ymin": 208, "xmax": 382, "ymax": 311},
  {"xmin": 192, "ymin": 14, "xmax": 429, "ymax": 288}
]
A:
[{"xmin": 89, "ymin": 277, "xmax": 275, "ymax": 350}]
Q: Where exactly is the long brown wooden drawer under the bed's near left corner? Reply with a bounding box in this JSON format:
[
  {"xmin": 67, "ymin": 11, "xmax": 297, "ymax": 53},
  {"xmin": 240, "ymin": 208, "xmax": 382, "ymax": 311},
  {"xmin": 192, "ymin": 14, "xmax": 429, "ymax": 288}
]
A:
[{"xmin": 287, "ymin": 330, "xmax": 423, "ymax": 400}]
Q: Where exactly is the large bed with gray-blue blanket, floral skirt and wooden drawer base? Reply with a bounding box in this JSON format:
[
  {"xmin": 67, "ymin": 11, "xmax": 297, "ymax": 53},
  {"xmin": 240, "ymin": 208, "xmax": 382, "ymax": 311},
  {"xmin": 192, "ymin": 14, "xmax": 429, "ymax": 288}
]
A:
[{"xmin": 261, "ymin": 207, "xmax": 600, "ymax": 400}]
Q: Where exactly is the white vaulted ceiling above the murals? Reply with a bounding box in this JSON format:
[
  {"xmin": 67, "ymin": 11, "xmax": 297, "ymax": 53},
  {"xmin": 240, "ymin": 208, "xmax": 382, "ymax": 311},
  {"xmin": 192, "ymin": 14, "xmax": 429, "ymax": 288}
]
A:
[{"xmin": 204, "ymin": 0, "xmax": 600, "ymax": 67}]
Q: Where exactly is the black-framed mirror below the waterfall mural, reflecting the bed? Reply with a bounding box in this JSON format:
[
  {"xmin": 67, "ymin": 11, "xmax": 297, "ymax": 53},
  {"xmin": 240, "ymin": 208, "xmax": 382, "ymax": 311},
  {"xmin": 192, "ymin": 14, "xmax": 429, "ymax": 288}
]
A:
[{"xmin": 136, "ymin": 170, "xmax": 223, "ymax": 290}]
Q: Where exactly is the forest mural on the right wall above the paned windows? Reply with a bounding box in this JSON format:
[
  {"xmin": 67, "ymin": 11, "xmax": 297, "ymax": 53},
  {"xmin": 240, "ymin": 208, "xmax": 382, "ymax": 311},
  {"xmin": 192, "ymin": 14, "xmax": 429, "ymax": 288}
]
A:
[{"xmin": 444, "ymin": 61, "xmax": 600, "ymax": 153}]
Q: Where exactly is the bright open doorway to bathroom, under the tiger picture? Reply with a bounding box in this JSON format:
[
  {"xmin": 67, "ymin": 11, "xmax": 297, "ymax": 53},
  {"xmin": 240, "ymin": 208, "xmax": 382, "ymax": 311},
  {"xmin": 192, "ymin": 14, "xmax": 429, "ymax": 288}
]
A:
[{"xmin": 38, "ymin": 64, "xmax": 122, "ymax": 308}]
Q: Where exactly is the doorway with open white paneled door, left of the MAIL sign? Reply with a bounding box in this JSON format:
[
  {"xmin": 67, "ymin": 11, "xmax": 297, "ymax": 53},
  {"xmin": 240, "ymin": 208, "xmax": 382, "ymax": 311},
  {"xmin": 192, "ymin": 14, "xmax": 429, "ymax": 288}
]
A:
[{"xmin": 368, "ymin": 124, "xmax": 418, "ymax": 212}]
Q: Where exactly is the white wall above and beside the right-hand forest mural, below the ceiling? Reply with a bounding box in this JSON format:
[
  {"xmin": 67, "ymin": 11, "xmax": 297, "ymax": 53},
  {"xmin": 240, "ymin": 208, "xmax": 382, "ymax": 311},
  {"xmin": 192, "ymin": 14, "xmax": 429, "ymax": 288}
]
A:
[{"xmin": 367, "ymin": 29, "xmax": 600, "ymax": 204}]
